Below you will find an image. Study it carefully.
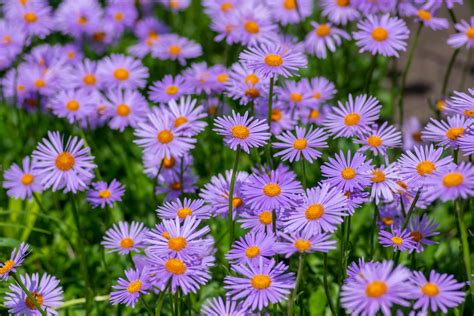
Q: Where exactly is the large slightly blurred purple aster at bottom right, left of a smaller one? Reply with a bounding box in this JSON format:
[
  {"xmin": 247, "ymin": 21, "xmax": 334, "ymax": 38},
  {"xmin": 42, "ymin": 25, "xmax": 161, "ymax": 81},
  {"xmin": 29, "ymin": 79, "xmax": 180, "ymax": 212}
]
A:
[{"xmin": 341, "ymin": 261, "xmax": 411, "ymax": 316}]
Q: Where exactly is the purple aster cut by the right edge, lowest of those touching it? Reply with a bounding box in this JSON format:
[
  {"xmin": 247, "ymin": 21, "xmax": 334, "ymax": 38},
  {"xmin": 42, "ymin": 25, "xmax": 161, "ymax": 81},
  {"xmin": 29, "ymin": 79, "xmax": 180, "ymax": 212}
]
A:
[{"xmin": 422, "ymin": 161, "xmax": 474, "ymax": 202}]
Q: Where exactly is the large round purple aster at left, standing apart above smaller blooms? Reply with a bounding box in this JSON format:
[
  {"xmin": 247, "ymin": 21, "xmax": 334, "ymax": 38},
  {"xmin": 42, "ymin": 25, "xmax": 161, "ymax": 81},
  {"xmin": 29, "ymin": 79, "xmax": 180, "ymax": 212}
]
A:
[{"xmin": 32, "ymin": 132, "xmax": 97, "ymax": 193}]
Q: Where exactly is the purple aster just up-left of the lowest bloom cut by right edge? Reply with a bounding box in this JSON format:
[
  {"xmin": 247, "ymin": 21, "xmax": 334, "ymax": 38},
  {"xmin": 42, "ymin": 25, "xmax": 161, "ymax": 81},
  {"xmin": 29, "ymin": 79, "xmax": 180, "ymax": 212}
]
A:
[{"xmin": 398, "ymin": 145, "xmax": 453, "ymax": 188}]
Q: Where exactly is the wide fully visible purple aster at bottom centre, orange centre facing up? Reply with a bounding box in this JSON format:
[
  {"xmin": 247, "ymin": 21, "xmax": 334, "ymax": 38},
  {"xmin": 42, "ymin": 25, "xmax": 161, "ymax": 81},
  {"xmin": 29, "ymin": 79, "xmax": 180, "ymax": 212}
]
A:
[{"xmin": 224, "ymin": 258, "xmax": 295, "ymax": 311}]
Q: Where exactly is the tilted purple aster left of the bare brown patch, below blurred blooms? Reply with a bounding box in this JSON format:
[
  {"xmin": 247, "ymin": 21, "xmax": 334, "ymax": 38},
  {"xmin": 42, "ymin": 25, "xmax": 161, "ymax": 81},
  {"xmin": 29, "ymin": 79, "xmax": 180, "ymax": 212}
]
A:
[{"xmin": 324, "ymin": 94, "xmax": 382, "ymax": 137}]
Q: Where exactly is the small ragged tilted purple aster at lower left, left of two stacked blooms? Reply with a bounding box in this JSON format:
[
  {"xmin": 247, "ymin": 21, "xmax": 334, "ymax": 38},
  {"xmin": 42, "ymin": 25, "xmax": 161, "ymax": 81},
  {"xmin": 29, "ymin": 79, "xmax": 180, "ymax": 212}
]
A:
[{"xmin": 109, "ymin": 267, "xmax": 152, "ymax": 307}]
